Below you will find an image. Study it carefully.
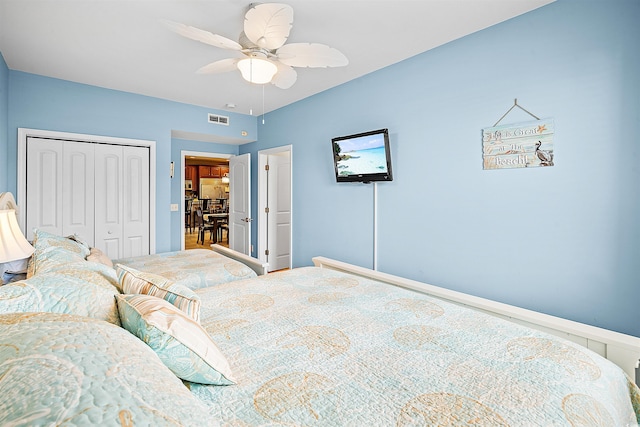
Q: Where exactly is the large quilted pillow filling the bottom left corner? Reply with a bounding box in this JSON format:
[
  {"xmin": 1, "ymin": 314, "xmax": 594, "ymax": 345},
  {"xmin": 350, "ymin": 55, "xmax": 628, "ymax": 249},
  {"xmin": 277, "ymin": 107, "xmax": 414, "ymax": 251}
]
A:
[{"xmin": 0, "ymin": 313, "xmax": 217, "ymax": 426}]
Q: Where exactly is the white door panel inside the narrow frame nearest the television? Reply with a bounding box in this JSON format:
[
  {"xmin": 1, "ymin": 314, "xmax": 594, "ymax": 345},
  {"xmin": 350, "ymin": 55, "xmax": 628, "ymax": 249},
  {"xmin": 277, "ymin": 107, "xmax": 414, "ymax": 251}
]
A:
[{"xmin": 267, "ymin": 151, "xmax": 291, "ymax": 271}]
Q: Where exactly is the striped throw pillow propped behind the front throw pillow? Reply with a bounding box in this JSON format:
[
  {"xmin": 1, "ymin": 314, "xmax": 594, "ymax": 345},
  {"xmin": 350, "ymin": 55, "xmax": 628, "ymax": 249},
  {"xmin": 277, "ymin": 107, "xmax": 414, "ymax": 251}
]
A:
[{"xmin": 116, "ymin": 264, "xmax": 200, "ymax": 322}]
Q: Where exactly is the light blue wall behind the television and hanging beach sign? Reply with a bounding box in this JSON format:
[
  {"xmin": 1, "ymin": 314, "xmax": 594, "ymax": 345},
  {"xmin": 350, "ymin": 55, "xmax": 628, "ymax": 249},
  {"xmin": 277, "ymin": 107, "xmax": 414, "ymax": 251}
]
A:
[{"xmin": 246, "ymin": 0, "xmax": 640, "ymax": 336}]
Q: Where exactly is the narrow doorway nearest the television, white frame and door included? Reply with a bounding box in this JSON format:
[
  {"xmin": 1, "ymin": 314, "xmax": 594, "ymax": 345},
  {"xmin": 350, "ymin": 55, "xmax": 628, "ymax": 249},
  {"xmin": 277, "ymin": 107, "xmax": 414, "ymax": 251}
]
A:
[{"xmin": 258, "ymin": 145, "xmax": 293, "ymax": 271}]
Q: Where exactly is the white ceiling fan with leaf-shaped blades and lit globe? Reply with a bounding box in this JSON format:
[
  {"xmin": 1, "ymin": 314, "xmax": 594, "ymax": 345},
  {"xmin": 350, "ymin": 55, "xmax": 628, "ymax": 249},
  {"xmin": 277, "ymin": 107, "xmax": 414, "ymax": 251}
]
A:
[{"xmin": 163, "ymin": 3, "xmax": 349, "ymax": 89}]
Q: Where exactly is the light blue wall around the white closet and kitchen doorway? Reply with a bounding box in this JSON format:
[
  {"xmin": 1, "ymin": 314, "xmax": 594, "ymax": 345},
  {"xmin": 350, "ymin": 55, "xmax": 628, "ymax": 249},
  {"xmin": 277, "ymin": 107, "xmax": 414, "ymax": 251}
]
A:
[{"xmin": 5, "ymin": 70, "xmax": 257, "ymax": 252}]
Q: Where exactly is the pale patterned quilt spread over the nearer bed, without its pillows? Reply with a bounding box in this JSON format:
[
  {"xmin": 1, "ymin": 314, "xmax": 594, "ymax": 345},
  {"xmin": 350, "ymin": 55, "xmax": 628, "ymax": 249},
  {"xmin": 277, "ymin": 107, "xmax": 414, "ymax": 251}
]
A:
[{"xmin": 190, "ymin": 266, "xmax": 640, "ymax": 426}]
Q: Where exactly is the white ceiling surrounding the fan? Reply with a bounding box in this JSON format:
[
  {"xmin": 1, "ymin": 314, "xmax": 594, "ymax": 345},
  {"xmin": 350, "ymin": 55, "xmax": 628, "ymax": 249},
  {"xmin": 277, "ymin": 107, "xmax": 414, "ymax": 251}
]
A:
[{"xmin": 0, "ymin": 0, "xmax": 553, "ymax": 115}]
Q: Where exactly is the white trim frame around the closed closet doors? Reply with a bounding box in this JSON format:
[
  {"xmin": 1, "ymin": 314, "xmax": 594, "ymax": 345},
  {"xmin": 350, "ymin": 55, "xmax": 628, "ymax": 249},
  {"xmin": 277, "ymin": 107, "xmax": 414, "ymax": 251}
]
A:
[{"xmin": 17, "ymin": 128, "xmax": 157, "ymax": 254}]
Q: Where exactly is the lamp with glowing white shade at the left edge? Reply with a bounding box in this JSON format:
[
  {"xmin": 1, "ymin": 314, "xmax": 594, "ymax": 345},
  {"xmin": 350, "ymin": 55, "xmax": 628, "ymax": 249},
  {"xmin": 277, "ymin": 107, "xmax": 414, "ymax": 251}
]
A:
[{"xmin": 0, "ymin": 209, "xmax": 35, "ymax": 284}]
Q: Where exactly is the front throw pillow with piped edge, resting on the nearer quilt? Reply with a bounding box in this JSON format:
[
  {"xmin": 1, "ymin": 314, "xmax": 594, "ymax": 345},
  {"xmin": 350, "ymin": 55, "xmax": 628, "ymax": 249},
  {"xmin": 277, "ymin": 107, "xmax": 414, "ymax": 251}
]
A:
[{"xmin": 116, "ymin": 295, "xmax": 234, "ymax": 385}]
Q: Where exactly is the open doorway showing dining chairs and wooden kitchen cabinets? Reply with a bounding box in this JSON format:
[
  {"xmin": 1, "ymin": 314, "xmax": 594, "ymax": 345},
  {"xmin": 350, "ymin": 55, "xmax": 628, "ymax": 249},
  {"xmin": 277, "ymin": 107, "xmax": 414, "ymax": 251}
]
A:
[{"xmin": 180, "ymin": 151, "xmax": 231, "ymax": 250}]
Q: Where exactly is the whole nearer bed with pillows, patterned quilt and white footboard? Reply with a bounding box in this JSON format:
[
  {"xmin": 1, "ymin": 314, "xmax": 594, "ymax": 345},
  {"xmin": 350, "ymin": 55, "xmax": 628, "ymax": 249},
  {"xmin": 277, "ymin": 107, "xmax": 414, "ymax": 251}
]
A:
[{"xmin": 0, "ymin": 232, "xmax": 640, "ymax": 426}]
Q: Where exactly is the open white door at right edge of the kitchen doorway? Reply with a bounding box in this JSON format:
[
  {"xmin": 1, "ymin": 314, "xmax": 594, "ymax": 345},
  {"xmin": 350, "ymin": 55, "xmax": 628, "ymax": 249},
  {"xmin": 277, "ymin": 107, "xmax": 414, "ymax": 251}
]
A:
[{"xmin": 229, "ymin": 153, "xmax": 251, "ymax": 255}]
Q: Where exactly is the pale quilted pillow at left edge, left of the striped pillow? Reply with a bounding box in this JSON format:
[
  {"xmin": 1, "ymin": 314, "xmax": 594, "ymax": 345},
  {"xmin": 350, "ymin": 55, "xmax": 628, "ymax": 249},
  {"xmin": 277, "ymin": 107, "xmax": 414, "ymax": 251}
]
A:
[{"xmin": 0, "ymin": 261, "xmax": 120, "ymax": 325}]
